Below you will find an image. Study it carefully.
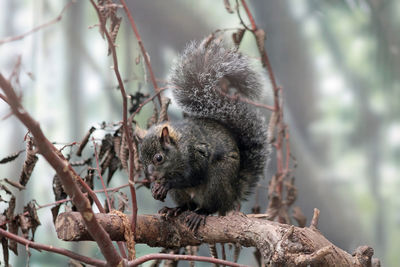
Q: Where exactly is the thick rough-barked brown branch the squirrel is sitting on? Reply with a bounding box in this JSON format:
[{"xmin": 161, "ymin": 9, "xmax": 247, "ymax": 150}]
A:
[{"xmin": 56, "ymin": 212, "xmax": 378, "ymax": 266}]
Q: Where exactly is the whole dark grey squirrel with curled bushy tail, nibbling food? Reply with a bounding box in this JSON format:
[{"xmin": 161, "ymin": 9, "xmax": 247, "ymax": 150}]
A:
[{"xmin": 137, "ymin": 41, "xmax": 268, "ymax": 231}]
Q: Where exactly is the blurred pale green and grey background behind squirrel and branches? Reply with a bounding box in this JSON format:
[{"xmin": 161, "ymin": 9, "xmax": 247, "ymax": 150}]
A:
[{"xmin": 0, "ymin": 0, "xmax": 400, "ymax": 266}]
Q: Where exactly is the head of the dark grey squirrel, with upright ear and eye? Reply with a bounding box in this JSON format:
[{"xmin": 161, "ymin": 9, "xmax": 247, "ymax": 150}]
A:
[{"xmin": 136, "ymin": 124, "xmax": 183, "ymax": 182}]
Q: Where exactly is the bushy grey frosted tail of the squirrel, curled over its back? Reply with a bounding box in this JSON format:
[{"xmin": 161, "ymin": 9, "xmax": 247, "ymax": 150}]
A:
[{"xmin": 170, "ymin": 41, "xmax": 268, "ymax": 198}]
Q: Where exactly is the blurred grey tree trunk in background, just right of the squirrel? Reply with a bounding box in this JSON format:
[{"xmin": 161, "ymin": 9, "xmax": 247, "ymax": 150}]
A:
[{"xmin": 252, "ymin": 1, "xmax": 360, "ymax": 253}]
